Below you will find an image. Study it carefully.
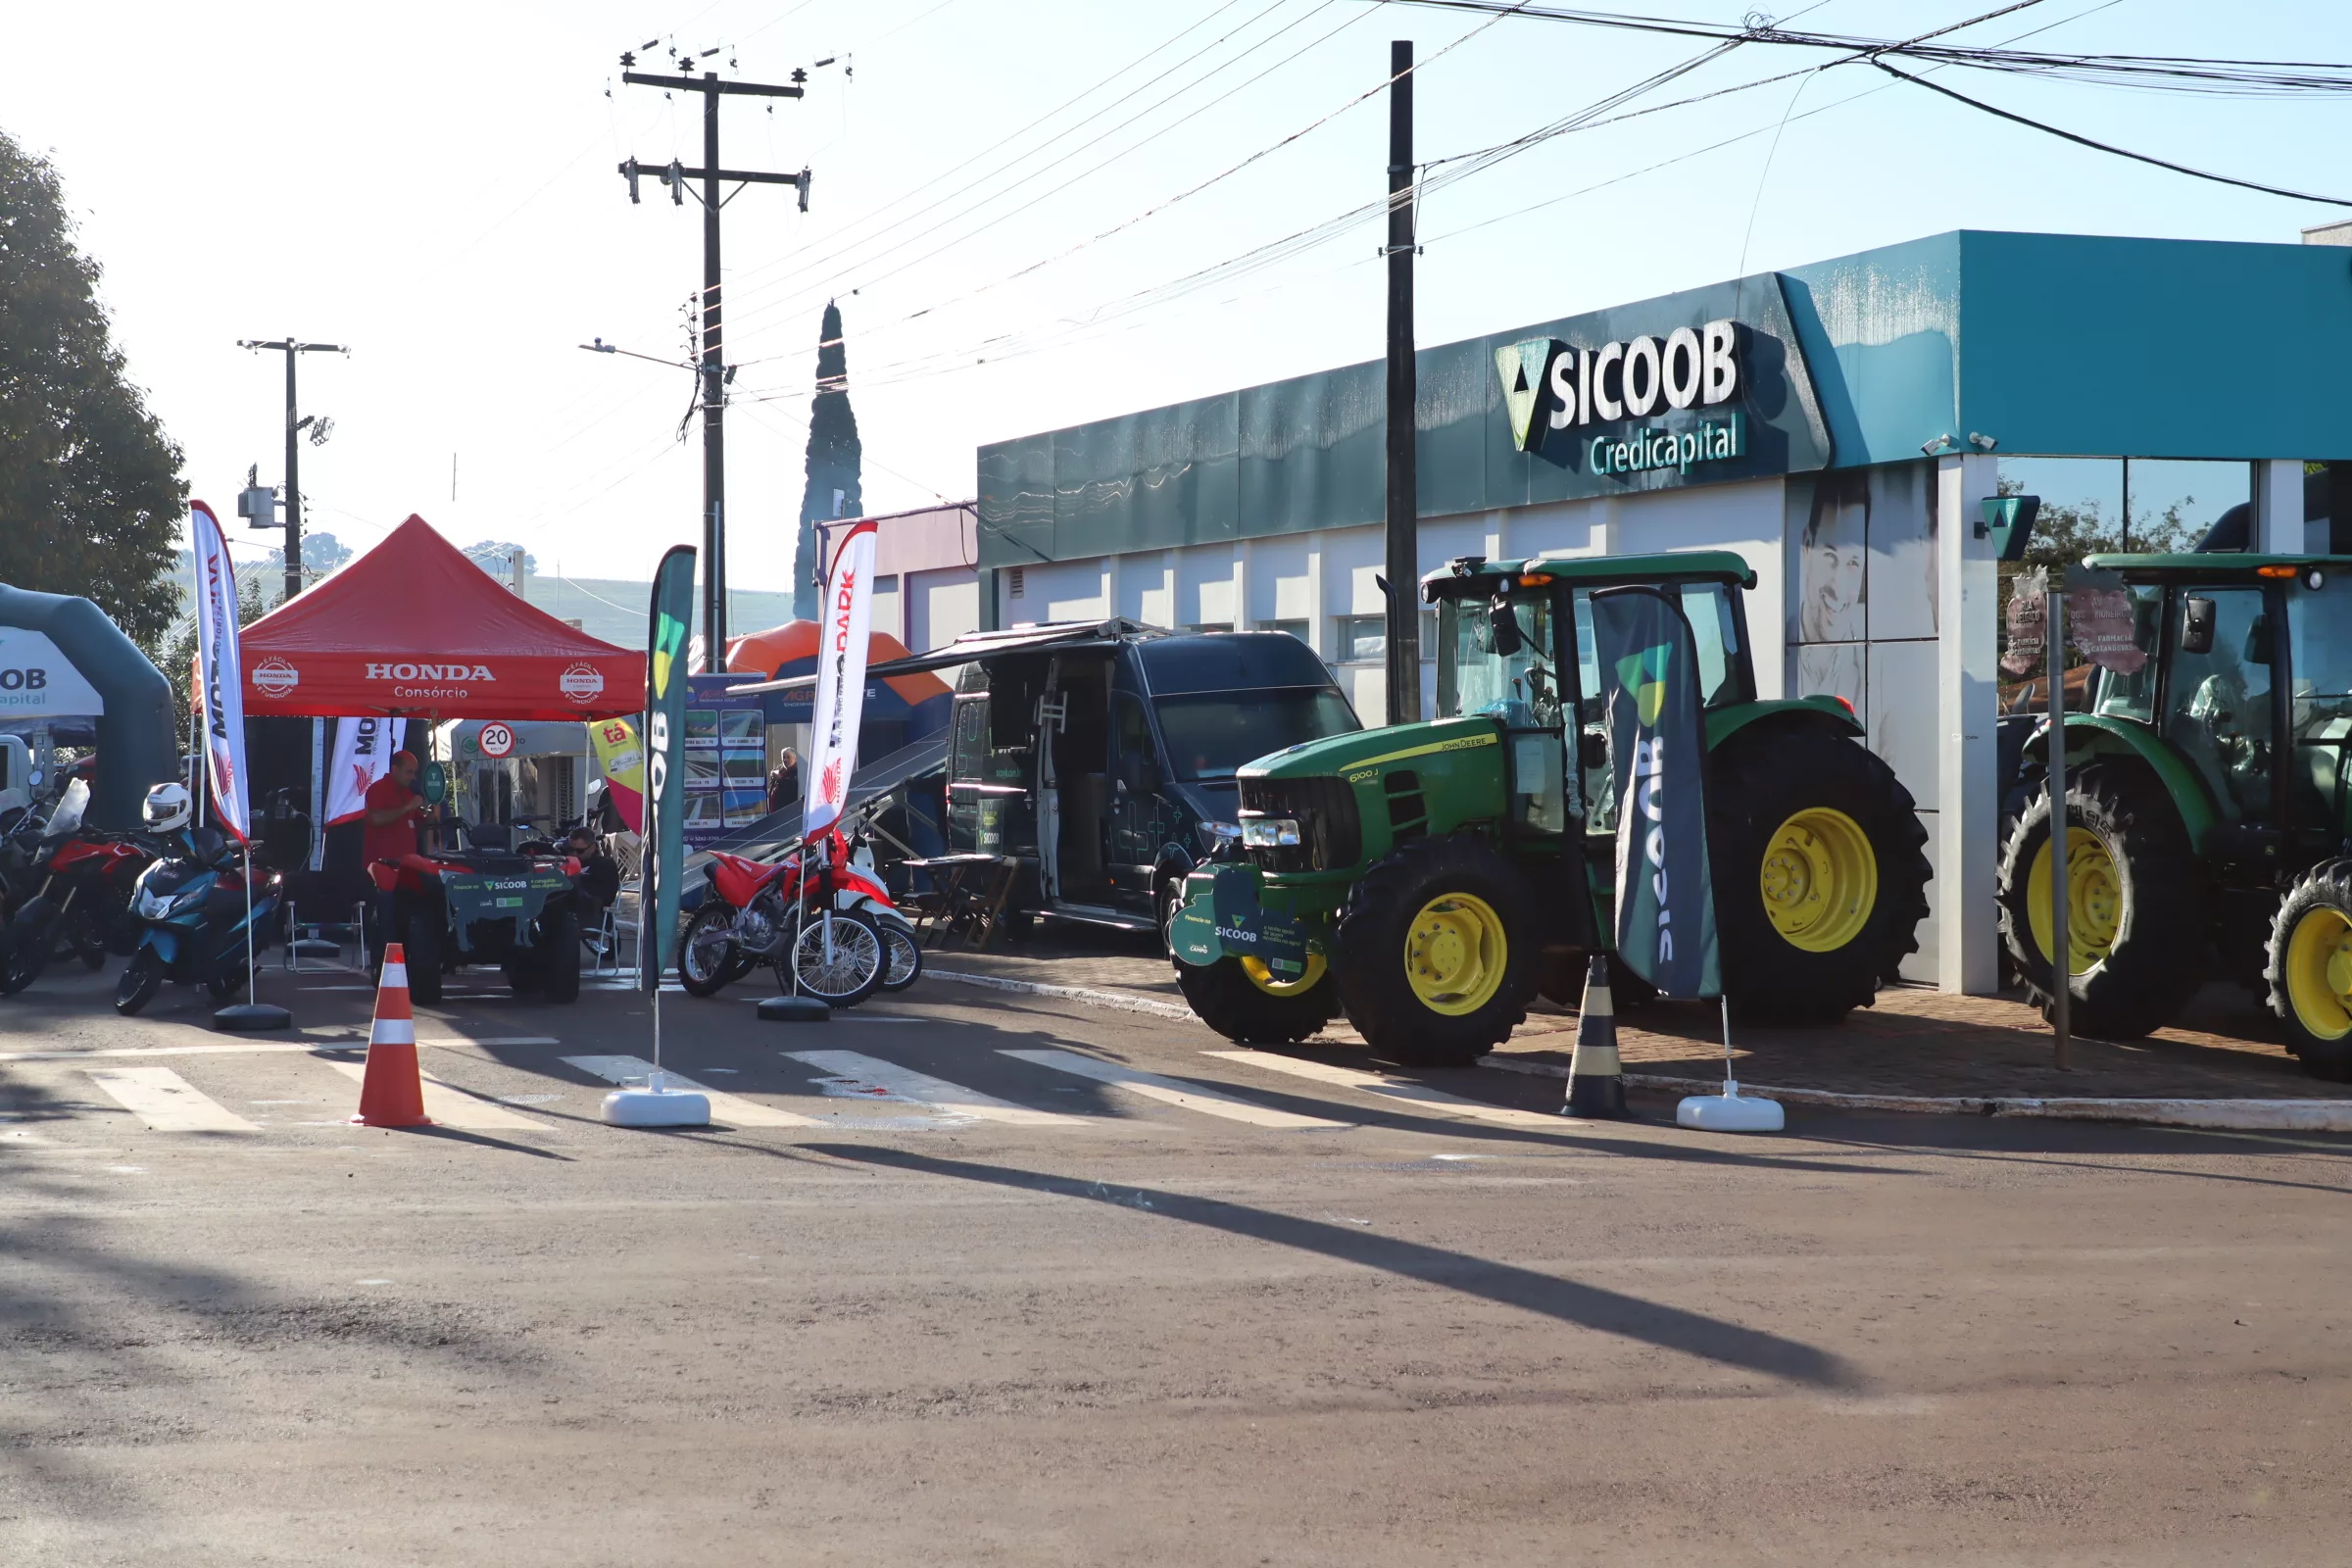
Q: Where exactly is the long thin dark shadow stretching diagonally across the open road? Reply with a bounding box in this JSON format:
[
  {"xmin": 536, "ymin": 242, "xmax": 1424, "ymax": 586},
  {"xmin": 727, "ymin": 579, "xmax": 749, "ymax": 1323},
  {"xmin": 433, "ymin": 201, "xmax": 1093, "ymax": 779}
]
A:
[{"xmin": 802, "ymin": 1143, "xmax": 1863, "ymax": 1390}]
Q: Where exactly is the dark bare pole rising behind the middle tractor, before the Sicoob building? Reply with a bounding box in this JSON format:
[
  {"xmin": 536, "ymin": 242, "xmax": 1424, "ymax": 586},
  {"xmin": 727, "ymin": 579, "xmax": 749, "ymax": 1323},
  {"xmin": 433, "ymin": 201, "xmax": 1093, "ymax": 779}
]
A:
[{"xmin": 1388, "ymin": 37, "xmax": 1421, "ymax": 724}]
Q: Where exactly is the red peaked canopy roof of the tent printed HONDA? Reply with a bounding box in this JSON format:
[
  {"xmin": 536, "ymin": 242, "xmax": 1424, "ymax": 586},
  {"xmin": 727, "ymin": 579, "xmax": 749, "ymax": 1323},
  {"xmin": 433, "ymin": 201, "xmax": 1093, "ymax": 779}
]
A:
[{"xmin": 240, "ymin": 517, "xmax": 645, "ymax": 719}]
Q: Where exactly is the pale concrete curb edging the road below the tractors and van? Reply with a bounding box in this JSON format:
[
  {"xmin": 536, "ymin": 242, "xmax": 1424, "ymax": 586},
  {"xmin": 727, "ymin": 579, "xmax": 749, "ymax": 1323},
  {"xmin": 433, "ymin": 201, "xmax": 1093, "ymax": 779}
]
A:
[{"xmin": 922, "ymin": 968, "xmax": 2352, "ymax": 1133}]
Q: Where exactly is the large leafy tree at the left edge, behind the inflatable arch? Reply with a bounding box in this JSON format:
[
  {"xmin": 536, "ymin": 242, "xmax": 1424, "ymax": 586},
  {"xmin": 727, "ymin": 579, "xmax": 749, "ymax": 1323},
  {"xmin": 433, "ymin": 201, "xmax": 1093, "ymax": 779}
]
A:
[{"xmin": 0, "ymin": 134, "xmax": 188, "ymax": 649}]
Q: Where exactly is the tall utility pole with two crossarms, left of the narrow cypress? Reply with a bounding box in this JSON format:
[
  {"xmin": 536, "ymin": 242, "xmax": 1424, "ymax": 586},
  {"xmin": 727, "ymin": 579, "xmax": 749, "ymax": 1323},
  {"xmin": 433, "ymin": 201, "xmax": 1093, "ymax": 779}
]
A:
[{"xmin": 621, "ymin": 45, "xmax": 809, "ymax": 670}]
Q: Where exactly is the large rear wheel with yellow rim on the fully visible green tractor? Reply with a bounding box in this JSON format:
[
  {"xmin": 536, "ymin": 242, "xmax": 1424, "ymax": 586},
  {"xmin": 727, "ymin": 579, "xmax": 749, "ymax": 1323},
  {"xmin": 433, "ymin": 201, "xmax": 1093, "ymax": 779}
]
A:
[{"xmin": 1712, "ymin": 726, "xmax": 1934, "ymax": 1025}]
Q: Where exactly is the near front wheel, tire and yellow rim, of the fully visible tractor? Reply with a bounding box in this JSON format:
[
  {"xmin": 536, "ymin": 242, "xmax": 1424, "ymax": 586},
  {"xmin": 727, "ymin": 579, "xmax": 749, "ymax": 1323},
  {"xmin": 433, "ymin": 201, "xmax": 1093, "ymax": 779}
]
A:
[{"xmin": 1331, "ymin": 837, "xmax": 1536, "ymax": 1067}]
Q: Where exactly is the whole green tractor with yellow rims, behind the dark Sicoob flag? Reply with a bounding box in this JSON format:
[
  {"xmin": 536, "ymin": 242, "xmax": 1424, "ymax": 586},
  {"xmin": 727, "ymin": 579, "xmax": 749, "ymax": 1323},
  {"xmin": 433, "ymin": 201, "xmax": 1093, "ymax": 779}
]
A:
[{"xmin": 1169, "ymin": 550, "xmax": 1929, "ymax": 1067}]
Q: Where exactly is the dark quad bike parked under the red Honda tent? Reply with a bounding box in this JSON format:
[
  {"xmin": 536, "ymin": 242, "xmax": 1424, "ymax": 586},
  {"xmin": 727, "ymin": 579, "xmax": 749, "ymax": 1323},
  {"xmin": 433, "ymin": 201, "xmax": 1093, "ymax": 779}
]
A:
[{"xmin": 367, "ymin": 851, "xmax": 581, "ymax": 1004}]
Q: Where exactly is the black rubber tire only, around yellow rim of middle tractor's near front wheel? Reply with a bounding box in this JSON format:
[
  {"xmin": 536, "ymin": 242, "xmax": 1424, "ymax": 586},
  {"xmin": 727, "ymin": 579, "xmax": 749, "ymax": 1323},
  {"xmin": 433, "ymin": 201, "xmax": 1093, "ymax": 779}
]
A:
[{"xmin": 1331, "ymin": 835, "xmax": 1536, "ymax": 1067}]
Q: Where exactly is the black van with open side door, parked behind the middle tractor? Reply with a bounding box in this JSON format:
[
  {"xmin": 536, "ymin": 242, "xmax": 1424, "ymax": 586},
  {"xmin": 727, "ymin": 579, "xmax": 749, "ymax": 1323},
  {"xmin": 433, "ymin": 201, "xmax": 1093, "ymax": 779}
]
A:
[{"xmin": 931, "ymin": 620, "xmax": 1362, "ymax": 931}]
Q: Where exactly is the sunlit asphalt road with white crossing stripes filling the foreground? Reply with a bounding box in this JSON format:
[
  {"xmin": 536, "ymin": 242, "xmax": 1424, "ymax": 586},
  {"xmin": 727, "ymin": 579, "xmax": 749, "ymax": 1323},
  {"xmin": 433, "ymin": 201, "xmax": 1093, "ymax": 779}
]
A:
[{"xmin": 0, "ymin": 973, "xmax": 2352, "ymax": 1568}]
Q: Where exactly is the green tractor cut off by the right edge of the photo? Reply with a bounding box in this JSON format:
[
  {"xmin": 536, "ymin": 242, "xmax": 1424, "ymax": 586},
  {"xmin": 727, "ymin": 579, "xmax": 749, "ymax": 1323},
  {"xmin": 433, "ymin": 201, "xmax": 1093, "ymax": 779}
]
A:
[{"xmin": 1999, "ymin": 553, "xmax": 2352, "ymax": 1079}]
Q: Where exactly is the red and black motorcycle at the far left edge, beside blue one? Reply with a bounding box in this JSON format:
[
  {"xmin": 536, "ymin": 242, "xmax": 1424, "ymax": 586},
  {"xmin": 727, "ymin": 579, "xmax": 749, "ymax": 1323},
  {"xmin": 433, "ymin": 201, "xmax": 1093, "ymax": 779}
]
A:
[{"xmin": 0, "ymin": 778, "xmax": 155, "ymax": 995}]
